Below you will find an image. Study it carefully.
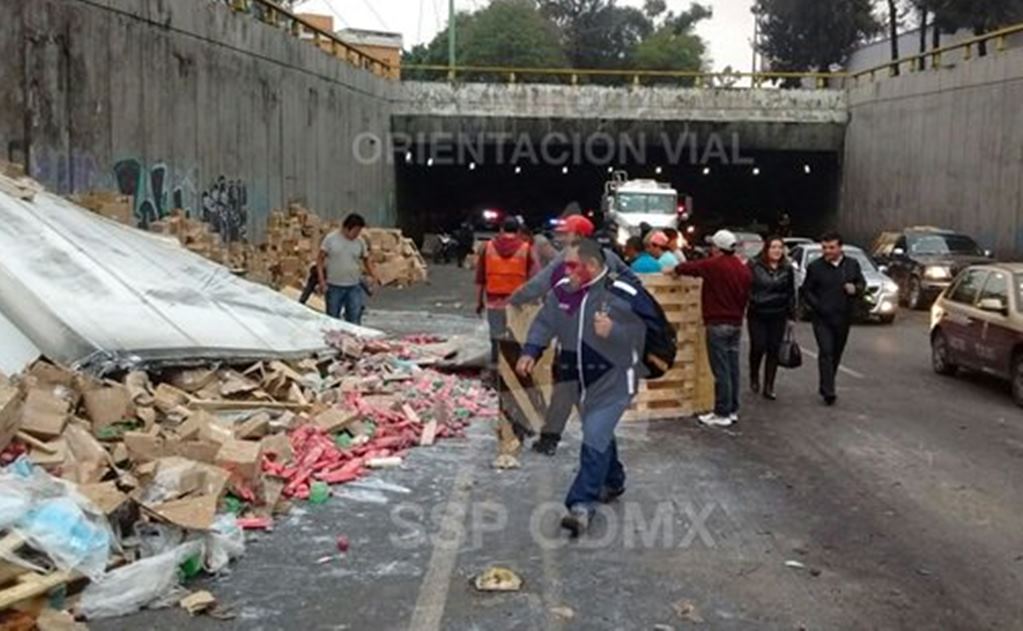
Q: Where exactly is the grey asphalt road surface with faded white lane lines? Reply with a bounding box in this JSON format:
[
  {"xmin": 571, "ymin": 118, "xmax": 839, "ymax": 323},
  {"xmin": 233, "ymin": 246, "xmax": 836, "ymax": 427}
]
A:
[{"xmin": 92, "ymin": 268, "xmax": 1023, "ymax": 631}]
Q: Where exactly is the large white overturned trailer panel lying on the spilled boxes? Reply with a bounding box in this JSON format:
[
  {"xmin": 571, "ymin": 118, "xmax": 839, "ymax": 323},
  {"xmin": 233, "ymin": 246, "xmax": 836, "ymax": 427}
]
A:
[{"xmin": 0, "ymin": 192, "xmax": 380, "ymax": 372}]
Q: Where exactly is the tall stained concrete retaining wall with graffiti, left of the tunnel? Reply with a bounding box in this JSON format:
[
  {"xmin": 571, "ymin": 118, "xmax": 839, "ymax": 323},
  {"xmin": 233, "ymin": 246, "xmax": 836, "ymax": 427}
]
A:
[{"xmin": 0, "ymin": 0, "xmax": 398, "ymax": 238}]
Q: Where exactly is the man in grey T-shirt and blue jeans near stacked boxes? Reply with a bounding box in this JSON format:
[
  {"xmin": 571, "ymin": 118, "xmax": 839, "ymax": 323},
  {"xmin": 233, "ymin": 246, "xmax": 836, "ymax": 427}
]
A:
[{"xmin": 316, "ymin": 213, "xmax": 376, "ymax": 324}]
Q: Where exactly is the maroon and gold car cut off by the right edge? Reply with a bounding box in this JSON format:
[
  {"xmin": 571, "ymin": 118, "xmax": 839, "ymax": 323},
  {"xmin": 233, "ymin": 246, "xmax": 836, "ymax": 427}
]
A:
[{"xmin": 931, "ymin": 263, "xmax": 1023, "ymax": 406}]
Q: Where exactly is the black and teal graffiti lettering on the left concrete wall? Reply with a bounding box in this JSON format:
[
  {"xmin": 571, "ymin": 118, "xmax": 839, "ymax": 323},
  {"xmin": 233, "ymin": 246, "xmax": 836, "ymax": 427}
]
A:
[{"xmin": 114, "ymin": 159, "xmax": 249, "ymax": 243}]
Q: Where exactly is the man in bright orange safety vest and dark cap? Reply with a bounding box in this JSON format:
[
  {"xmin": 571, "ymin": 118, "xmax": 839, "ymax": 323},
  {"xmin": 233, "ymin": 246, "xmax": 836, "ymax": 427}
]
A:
[{"xmin": 476, "ymin": 218, "xmax": 537, "ymax": 366}]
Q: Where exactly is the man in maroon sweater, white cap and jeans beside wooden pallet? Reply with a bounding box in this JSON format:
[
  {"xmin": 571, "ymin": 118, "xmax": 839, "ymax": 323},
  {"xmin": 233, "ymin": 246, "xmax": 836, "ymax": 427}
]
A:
[{"xmin": 674, "ymin": 230, "xmax": 753, "ymax": 427}]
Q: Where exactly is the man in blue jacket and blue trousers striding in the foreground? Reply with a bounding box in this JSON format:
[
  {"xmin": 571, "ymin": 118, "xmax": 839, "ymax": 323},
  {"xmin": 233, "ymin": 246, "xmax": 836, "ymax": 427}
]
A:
[{"xmin": 516, "ymin": 240, "xmax": 654, "ymax": 536}]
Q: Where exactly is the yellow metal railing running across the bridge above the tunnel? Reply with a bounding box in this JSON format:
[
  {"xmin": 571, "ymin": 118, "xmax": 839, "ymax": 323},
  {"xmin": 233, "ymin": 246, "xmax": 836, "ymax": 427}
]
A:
[{"xmin": 402, "ymin": 64, "xmax": 848, "ymax": 88}]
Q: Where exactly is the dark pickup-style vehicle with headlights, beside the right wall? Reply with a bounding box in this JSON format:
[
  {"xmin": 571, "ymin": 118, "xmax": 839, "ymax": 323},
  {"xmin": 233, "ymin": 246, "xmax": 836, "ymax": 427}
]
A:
[{"xmin": 873, "ymin": 227, "xmax": 991, "ymax": 309}]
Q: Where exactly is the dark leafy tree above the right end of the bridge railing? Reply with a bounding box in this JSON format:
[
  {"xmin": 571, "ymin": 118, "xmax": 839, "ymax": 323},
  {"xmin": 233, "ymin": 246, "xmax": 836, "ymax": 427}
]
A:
[{"xmin": 753, "ymin": 0, "xmax": 882, "ymax": 75}]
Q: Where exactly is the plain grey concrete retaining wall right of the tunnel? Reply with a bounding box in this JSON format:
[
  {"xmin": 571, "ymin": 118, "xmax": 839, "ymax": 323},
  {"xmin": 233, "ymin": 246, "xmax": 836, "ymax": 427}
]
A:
[{"xmin": 840, "ymin": 49, "xmax": 1023, "ymax": 258}]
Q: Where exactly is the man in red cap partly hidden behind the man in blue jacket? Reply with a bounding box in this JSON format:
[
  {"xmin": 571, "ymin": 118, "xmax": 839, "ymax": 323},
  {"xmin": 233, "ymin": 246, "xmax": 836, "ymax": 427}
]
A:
[{"xmin": 508, "ymin": 215, "xmax": 637, "ymax": 456}]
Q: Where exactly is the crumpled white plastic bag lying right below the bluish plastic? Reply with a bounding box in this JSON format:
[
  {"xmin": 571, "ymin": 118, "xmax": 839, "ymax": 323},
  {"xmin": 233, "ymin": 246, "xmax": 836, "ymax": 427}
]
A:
[{"xmin": 78, "ymin": 541, "xmax": 202, "ymax": 620}]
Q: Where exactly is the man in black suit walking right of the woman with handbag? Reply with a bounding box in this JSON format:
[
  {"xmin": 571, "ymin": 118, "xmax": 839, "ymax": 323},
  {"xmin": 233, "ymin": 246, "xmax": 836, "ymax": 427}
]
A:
[{"xmin": 803, "ymin": 232, "xmax": 866, "ymax": 405}]
